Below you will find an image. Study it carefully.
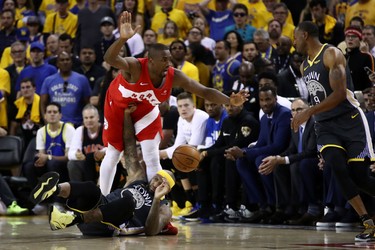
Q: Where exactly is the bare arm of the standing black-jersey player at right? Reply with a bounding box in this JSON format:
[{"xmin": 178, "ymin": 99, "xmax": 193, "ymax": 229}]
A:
[{"xmin": 291, "ymin": 47, "xmax": 347, "ymax": 132}]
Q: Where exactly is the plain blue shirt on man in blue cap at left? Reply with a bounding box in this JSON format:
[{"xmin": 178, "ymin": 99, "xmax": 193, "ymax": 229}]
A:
[{"xmin": 16, "ymin": 63, "xmax": 57, "ymax": 95}]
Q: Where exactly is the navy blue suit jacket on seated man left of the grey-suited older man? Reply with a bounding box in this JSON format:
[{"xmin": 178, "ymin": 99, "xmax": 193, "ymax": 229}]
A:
[{"xmin": 245, "ymin": 103, "xmax": 292, "ymax": 161}]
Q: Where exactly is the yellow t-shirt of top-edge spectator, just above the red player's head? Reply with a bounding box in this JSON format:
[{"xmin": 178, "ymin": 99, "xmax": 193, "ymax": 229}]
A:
[{"xmin": 151, "ymin": 9, "xmax": 192, "ymax": 38}]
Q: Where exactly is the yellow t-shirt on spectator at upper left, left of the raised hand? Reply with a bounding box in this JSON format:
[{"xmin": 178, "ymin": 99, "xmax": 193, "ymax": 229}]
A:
[{"xmin": 43, "ymin": 11, "xmax": 78, "ymax": 38}]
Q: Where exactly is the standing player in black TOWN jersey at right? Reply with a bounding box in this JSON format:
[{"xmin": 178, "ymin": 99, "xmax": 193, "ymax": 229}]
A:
[{"xmin": 292, "ymin": 22, "xmax": 375, "ymax": 241}]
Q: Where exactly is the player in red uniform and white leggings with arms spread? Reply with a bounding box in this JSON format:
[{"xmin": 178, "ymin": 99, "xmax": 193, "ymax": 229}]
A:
[{"xmin": 100, "ymin": 12, "xmax": 247, "ymax": 194}]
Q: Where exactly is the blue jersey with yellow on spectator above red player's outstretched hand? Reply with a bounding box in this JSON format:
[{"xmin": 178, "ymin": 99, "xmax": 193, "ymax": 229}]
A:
[{"xmin": 212, "ymin": 59, "xmax": 241, "ymax": 91}]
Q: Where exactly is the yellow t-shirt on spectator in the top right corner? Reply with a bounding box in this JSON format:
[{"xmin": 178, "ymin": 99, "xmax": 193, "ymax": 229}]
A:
[{"xmin": 345, "ymin": 0, "xmax": 375, "ymax": 27}]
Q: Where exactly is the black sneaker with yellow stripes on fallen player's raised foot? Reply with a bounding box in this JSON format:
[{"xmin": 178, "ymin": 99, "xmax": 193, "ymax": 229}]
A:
[{"xmin": 30, "ymin": 172, "xmax": 60, "ymax": 204}]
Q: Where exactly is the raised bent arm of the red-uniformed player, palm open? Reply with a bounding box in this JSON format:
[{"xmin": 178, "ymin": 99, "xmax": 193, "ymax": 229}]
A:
[{"xmin": 104, "ymin": 11, "xmax": 141, "ymax": 72}]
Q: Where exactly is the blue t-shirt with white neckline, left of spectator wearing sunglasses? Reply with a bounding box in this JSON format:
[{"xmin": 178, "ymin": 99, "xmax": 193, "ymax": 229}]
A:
[{"xmin": 206, "ymin": 10, "xmax": 234, "ymax": 41}]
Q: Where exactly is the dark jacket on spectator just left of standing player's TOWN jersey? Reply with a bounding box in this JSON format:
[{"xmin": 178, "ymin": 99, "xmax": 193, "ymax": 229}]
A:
[{"xmin": 277, "ymin": 67, "xmax": 301, "ymax": 97}]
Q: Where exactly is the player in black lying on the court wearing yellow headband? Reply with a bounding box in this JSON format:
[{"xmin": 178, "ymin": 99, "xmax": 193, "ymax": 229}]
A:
[{"xmin": 30, "ymin": 106, "xmax": 177, "ymax": 236}]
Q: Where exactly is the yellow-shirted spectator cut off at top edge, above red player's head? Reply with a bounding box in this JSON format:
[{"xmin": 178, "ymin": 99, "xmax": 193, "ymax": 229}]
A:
[{"xmin": 151, "ymin": 0, "xmax": 191, "ymax": 38}]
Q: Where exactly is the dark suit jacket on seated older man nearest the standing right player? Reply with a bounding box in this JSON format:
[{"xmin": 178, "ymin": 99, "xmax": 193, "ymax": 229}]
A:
[{"xmin": 281, "ymin": 118, "xmax": 318, "ymax": 164}]
